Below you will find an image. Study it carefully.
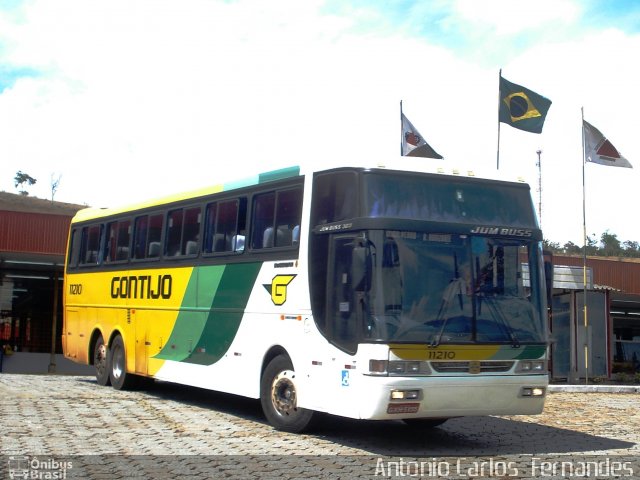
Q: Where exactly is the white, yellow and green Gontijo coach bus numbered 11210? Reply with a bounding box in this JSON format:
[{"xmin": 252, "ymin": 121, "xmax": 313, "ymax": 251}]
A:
[{"xmin": 63, "ymin": 163, "xmax": 548, "ymax": 432}]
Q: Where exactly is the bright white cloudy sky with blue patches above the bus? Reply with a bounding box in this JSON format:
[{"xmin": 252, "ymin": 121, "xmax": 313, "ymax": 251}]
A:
[{"xmin": 0, "ymin": 0, "xmax": 640, "ymax": 245}]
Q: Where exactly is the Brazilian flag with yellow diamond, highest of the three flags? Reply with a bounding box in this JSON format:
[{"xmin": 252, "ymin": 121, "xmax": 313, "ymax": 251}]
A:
[{"xmin": 499, "ymin": 75, "xmax": 551, "ymax": 133}]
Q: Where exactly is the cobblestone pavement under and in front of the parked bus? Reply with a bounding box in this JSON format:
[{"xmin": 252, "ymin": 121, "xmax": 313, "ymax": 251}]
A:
[{"xmin": 0, "ymin": 374, "xmax": 640, "ymax": 479}]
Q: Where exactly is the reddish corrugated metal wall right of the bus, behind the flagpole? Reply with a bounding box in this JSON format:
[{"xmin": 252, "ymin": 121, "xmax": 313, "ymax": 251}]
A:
[{"xmin": 553, "ymin": 255, "xmax": 640, "ymax": 295}]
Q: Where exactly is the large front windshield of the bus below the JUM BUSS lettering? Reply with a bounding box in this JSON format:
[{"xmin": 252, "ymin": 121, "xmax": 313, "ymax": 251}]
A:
[{"xmin": 362, "ymin": 231, "xmax": 546, "ymax": 346}]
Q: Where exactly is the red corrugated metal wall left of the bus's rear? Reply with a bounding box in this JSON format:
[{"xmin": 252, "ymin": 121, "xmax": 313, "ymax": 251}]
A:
[{"xmin": 0, "ymin": 211, "xmax": 71, "ymax": 255}]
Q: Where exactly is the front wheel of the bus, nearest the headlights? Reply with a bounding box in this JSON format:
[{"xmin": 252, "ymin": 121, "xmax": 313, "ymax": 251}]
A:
[{"xmin": 260, "ymin": 355, "xmax": 314, "ymax": 433}]
